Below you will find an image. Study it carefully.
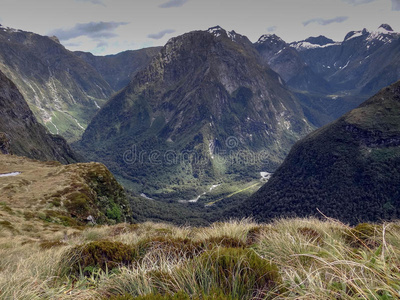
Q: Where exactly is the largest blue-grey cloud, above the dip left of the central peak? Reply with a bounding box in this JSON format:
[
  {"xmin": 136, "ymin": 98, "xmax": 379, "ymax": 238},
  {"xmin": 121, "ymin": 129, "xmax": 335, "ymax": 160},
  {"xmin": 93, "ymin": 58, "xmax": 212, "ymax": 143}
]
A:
[{"xmin": 50, "ymin": 22, "xmax": 128, "ymax": 41}]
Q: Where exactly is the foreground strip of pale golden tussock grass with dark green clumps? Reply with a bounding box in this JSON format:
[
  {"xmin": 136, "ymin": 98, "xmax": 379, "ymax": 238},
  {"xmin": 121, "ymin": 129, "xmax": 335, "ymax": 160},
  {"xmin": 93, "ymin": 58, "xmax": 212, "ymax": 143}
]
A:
[{"xmin": 0, "ymin": 219, "xmax": 400, "ymax": 299}]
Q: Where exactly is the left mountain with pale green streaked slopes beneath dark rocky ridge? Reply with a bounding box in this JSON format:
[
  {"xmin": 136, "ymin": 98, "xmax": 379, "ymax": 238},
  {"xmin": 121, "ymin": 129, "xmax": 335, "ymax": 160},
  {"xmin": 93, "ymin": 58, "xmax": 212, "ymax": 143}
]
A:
[{"xmin": 0, "ymin": 26, "xmax": 113, "ymax": 141}]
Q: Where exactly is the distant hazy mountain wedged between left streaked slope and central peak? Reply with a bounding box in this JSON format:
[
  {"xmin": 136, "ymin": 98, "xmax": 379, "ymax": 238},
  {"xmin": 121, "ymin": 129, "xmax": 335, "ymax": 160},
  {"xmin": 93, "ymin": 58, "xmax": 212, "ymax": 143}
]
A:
[{"xmin": 74, "ymin": 47, "xmax": 161, "ymax": 91}]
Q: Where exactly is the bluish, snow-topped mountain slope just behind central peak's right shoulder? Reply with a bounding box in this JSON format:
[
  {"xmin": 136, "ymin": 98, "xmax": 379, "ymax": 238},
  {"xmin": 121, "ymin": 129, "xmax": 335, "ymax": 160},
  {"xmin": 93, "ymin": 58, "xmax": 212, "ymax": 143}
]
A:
[{"xmin": 254, "ymin": 34, "xmax": 330, "ymax": 93}]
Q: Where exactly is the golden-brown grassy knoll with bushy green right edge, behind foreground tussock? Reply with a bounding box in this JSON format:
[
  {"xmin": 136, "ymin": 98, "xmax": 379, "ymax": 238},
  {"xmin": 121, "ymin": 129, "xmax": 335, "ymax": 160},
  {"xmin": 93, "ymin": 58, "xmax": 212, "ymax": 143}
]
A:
[{"xmin": 0, "ymin": 154, "xmax": 132, "ymax": 224}]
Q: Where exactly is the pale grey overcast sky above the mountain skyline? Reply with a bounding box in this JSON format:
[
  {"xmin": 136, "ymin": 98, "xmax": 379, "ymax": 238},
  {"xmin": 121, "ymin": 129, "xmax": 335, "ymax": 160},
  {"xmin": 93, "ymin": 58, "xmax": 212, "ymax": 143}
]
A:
[{"xmin": 0, "ymin": 0, "xmax": 400, "ymax": 55}]
